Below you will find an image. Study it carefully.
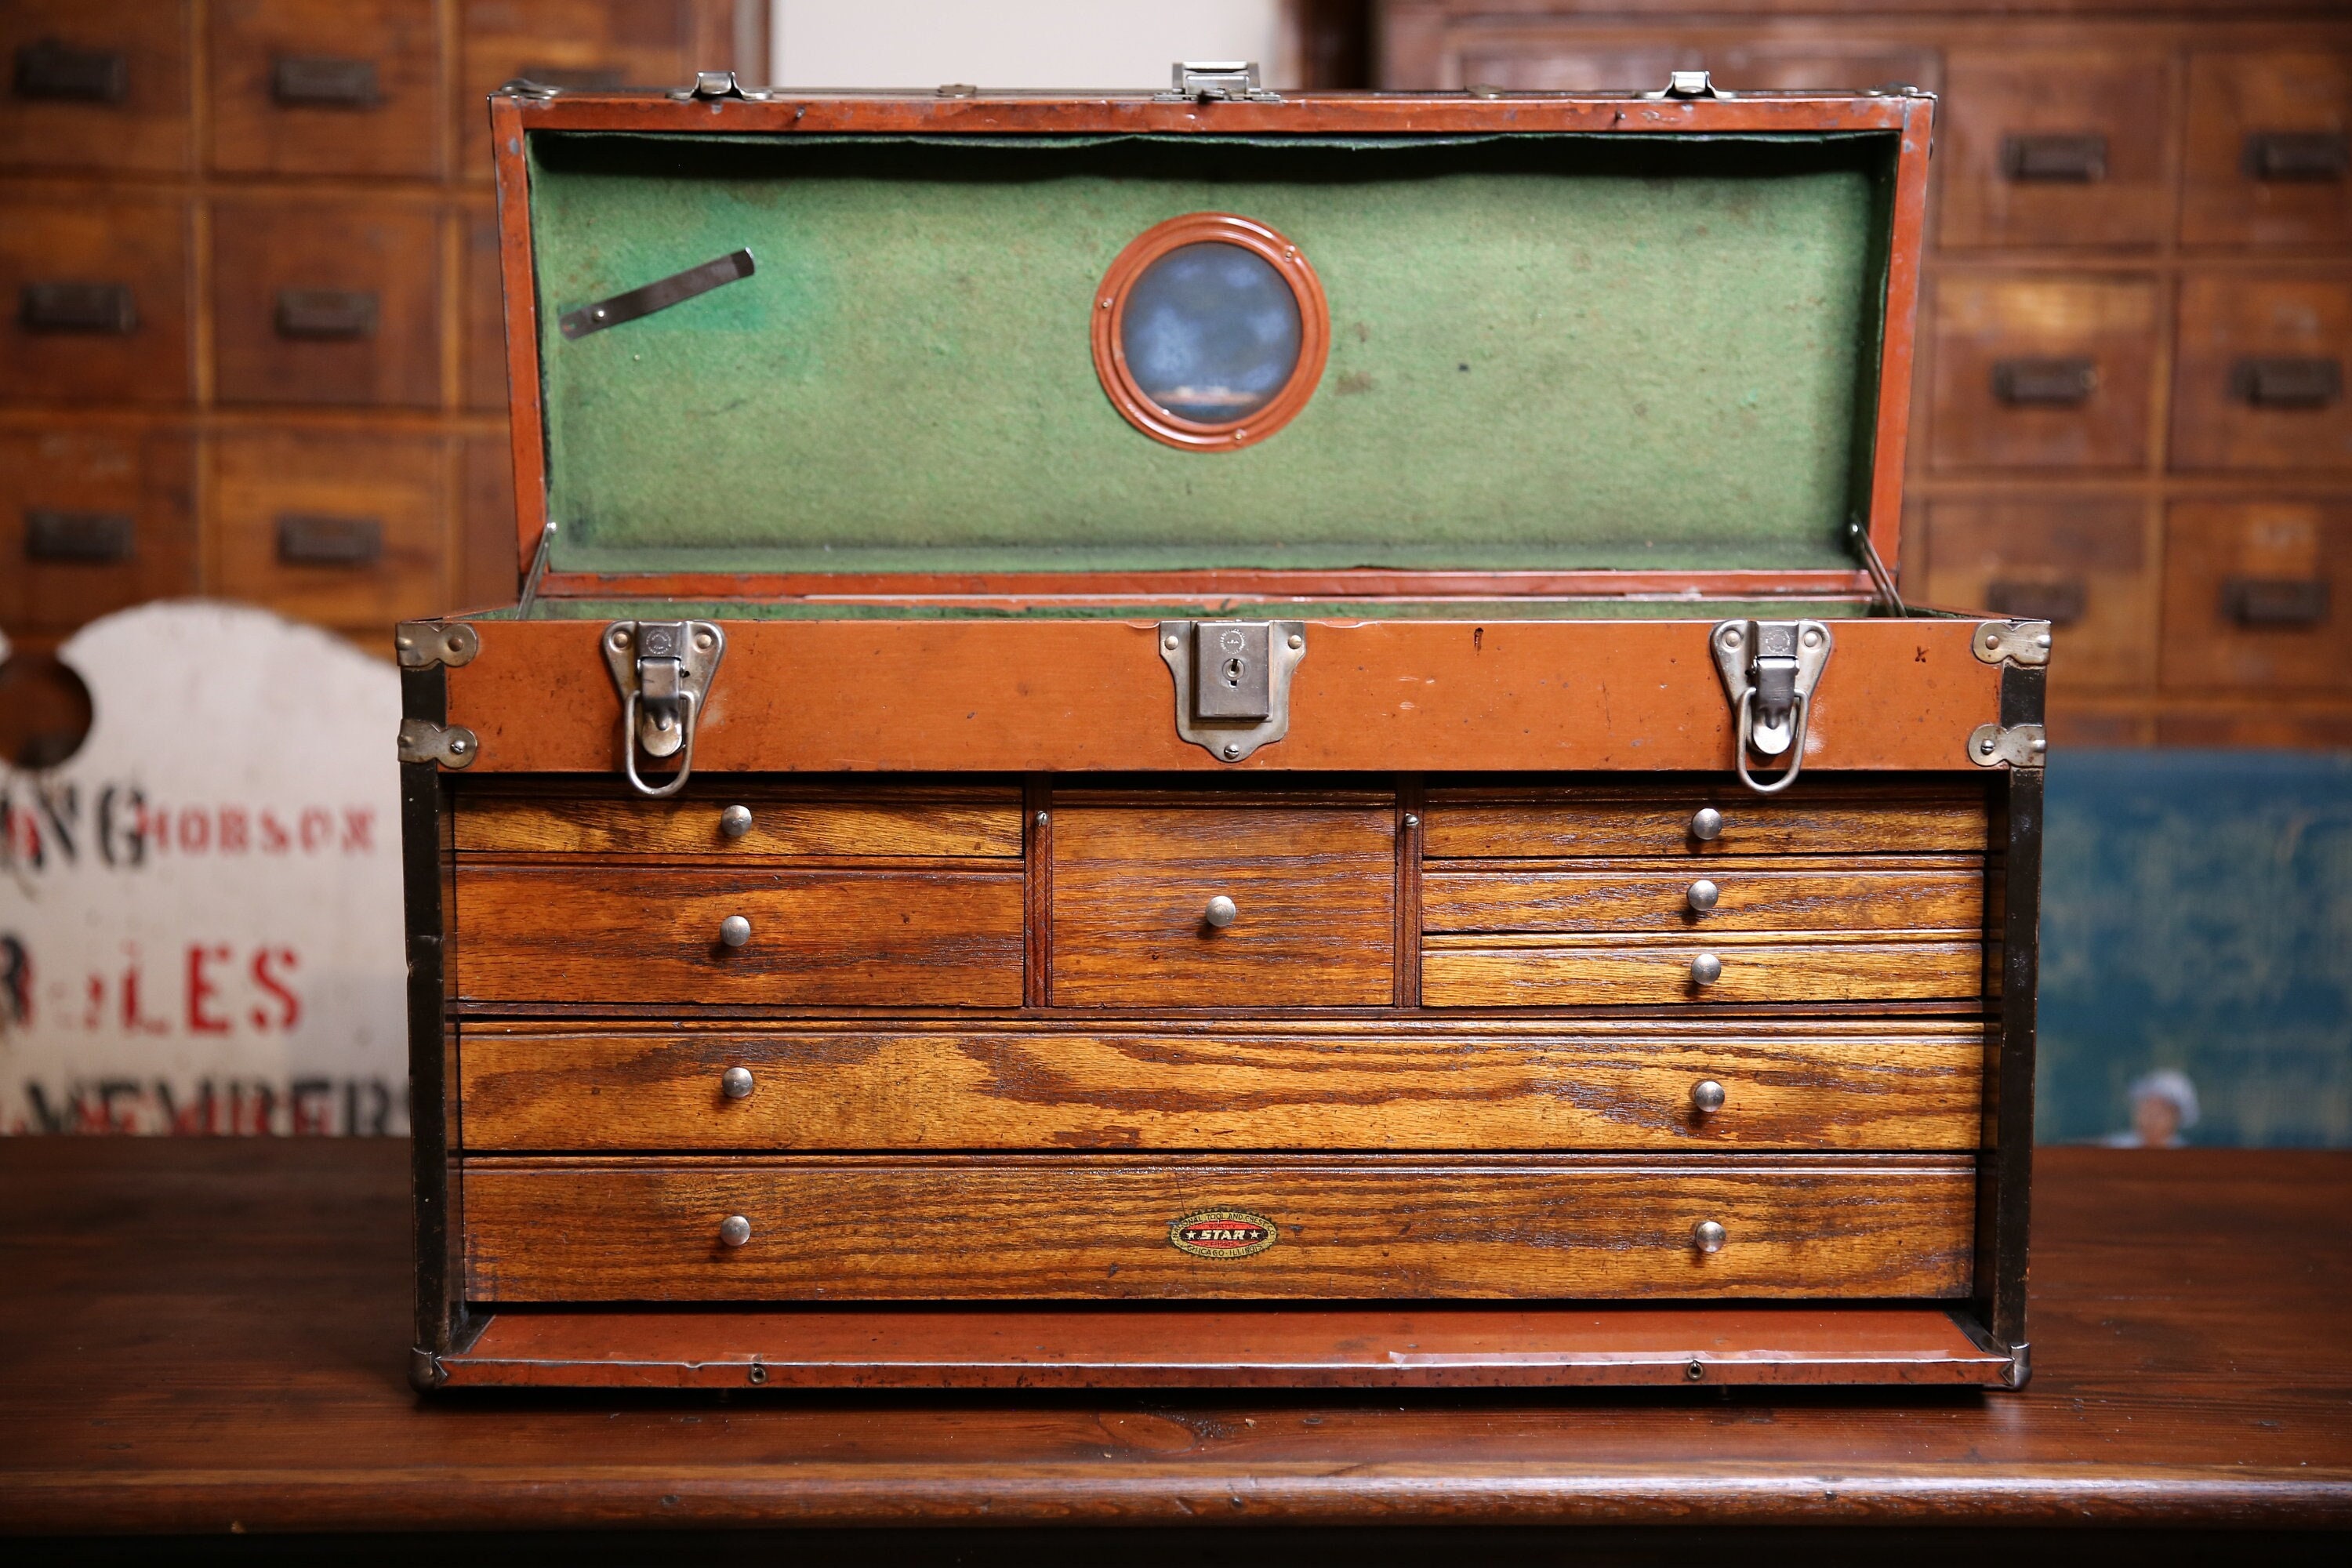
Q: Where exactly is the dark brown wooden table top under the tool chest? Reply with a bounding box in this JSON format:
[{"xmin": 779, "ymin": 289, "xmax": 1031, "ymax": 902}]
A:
[{"xmin": 0, "ymin": 1138, "xmax": 2352, "ymax": 1533}]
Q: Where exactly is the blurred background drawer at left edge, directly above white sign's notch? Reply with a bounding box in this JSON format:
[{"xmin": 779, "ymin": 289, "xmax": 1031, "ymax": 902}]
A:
[{"xmin": 0, "ymin": 430, "xmax": 195, "ymax": 633}]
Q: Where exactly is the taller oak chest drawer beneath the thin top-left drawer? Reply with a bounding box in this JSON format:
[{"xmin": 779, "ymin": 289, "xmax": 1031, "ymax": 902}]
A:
[{"xmin": 456, "ymin": 862, "xmax": 1025, "ymax": 1006}]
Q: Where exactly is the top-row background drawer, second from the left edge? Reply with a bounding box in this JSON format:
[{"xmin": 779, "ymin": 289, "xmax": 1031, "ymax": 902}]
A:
[{"xmin": 209, "ymin": 0, "xmax": 447, "ymax": 179}]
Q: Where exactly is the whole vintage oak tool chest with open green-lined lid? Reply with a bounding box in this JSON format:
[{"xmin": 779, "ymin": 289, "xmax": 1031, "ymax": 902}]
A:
[{"xmin": 397, "ymin": 66, "xmax": 2049, "ymax": 1387}]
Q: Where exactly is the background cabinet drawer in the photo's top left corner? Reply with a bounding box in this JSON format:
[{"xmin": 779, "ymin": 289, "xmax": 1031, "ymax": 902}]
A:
[{"xmin": 0, "ymin": 0, "xmax": 188, "ymax": 174}]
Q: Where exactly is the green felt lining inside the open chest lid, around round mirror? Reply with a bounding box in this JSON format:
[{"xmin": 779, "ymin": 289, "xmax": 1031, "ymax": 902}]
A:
[{"xmin": 529, "ymin": 132, "xmax": 1893, "ymax": 572}]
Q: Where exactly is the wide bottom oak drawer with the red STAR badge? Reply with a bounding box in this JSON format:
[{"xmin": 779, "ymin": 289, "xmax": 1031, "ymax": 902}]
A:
[{"xmin": 466, "ymin": 1154, "xmax": 1976, "ymax": 1302}]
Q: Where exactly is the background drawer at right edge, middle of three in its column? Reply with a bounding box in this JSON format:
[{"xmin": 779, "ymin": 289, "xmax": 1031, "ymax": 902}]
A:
[{"xmin": 2173, "ymin": 273, "xmax": 2352, "ymax": 470}]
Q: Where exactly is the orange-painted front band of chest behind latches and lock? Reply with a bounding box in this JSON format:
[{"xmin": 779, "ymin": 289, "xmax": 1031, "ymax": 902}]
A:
[{"xmin": 449, "ymin": 621, "xmax": 2002, "ymax": 774}]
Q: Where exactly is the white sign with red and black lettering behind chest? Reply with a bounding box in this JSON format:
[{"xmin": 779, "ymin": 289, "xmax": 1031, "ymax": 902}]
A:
[{"xmin": 0, "ymin": 602, "xmax": 409, "ymax": 1135}]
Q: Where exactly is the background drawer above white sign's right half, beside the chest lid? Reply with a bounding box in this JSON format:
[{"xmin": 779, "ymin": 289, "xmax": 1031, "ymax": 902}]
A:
[{"xmin": 205, "ymin": 433, "xmax": 449, "ymax": 630}]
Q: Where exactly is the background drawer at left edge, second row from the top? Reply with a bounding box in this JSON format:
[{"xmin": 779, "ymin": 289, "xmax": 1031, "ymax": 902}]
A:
[{"xmin": 0, "ymin": 195, "xmax": 195, "ymax": 402}]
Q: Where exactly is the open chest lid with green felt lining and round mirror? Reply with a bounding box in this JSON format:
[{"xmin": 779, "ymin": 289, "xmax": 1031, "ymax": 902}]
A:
[{"xmin": 492, "ymin": 78, "xmax": 1931, "ymax": 614}]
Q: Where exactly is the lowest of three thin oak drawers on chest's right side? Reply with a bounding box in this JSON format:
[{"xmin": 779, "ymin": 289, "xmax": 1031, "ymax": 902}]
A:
[{"xmin": 1421, "ymin": 931, "xmax": 1985, "ymax": 1006}]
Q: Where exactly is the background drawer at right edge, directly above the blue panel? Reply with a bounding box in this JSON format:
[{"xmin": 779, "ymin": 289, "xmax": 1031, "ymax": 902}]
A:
[{"xmin": 2161, "ymin": 501, "xmax": 2352, "ymax": 694}]
